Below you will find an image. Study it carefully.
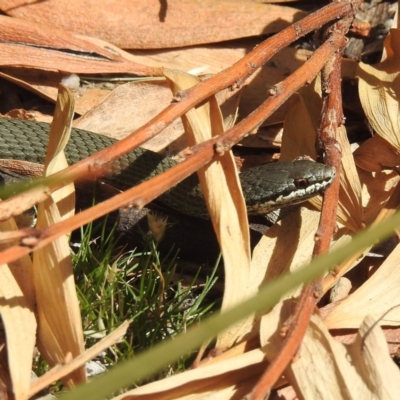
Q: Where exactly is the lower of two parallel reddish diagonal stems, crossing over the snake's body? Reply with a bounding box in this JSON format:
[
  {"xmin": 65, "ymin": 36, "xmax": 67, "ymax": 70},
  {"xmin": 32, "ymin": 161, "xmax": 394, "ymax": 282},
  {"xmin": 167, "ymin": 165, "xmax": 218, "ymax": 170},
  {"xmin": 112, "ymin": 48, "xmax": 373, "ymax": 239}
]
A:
[{"xmin": 0, "ymin": 33, "xmax": 345, "ymax": 263}]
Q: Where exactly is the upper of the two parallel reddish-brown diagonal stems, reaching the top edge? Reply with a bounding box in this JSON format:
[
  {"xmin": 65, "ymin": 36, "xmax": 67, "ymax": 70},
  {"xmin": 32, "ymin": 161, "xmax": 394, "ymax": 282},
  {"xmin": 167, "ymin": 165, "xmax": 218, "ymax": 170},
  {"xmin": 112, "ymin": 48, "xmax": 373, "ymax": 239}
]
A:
[{"xmin": 0, "ymin": 0, "xmax": 361, "ymax": 222}]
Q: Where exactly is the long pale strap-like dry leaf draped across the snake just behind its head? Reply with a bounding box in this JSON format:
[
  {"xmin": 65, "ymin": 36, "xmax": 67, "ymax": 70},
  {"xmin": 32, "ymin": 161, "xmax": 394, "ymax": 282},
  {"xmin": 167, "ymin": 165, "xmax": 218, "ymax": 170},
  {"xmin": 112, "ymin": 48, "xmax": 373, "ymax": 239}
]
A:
[{"xmin": 165, "ymin": 70, "xmax": 250, "ymax": 349}]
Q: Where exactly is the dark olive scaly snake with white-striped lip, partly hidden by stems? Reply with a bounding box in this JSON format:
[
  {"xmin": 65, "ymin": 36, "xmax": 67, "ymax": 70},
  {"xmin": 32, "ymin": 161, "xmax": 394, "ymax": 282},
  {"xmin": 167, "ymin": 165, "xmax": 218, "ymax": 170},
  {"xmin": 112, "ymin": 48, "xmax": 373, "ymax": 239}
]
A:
[{"xmin": 0, "ymin": 118, "xmax": 335, "ymax": 218}]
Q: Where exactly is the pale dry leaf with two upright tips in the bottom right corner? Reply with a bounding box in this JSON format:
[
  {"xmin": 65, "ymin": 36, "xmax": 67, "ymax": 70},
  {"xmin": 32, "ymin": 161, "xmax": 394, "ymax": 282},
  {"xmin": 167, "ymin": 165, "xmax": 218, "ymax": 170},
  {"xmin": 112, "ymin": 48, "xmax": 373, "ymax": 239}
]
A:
[{"xmin": 286, "ymin": 315, "xmax": 400, "ymax": 400}]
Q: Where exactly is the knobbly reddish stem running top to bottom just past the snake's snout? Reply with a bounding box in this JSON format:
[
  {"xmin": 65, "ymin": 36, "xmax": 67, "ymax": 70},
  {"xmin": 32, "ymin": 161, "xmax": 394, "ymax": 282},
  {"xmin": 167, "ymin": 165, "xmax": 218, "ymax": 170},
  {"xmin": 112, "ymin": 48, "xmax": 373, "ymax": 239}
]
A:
[{"xmin": 251, "ymin": 19, "xmax": 351, "ymax": 400}]
